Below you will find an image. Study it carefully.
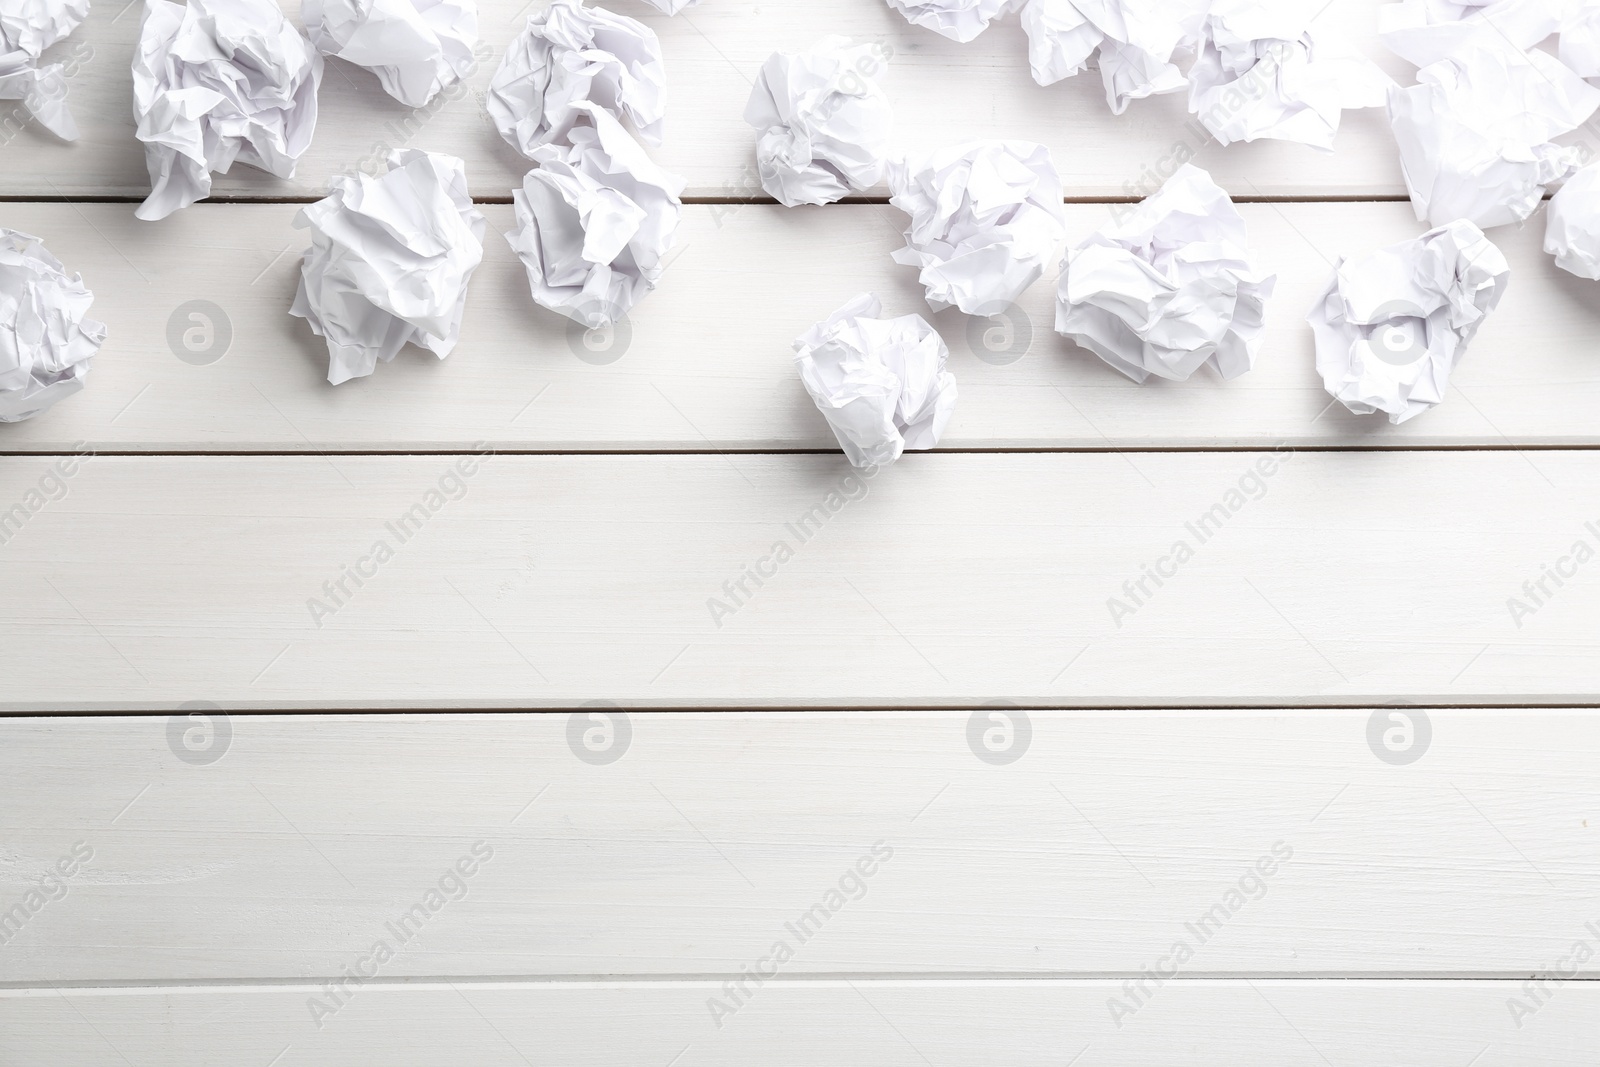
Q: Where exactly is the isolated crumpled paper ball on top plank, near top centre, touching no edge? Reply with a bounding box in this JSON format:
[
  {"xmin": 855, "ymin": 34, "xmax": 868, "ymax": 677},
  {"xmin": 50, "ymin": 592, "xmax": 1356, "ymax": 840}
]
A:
[{"xmin": 744, "ymin": 37, "xmax": 894, "ymax": 208}]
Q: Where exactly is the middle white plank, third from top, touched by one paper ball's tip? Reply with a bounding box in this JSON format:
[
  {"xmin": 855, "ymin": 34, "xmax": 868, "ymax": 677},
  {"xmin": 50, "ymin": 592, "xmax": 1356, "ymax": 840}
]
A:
[{"xmin": 0, "ymin": 451, "xmax": 1600, "ymax": 710}]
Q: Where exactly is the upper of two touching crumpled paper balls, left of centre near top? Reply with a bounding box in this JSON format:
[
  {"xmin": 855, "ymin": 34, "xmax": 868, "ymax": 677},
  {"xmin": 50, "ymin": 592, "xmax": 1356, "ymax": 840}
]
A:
[{"xmin": 485, "ymin": 0, "xmax": 667, "ymax": 158}]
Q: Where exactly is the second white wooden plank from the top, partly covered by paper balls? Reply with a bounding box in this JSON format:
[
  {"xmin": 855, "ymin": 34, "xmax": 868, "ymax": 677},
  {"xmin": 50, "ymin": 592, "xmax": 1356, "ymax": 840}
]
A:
[{"xmin": 0, "ymin": 203, "xmax": 1600, "ymax": 451}]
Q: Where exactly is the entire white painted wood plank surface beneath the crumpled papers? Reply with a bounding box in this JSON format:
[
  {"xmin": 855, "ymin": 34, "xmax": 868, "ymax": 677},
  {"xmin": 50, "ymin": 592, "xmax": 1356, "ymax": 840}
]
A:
[{"xmin": 0, "ymin": 0, "xmax": 1600, "ymax": 1067}]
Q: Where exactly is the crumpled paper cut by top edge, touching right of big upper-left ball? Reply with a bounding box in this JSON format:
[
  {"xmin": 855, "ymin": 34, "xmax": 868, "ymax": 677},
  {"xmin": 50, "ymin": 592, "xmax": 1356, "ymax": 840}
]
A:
[{"xmin": 301, "ymin": 0, "xmax": 478, "ymax": 107}]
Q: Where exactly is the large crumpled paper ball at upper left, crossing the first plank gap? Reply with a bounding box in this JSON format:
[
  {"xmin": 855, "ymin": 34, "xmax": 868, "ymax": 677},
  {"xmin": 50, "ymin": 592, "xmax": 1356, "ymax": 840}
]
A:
[{"xmin": 133, "ymin": 0, "xmax": 322, "ymax": 219}]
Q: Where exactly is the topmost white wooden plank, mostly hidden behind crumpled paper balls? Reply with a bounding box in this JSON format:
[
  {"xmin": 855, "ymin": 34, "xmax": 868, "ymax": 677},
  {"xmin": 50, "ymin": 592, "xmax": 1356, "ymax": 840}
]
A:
[{"xmin": 0, "ymin": 0, "xmax": 1411, "ymax": 198}]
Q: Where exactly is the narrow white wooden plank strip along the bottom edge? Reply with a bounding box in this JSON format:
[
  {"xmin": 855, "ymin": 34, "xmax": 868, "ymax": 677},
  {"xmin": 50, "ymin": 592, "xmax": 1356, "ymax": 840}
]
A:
[{"xmin": 0, "ymin": 981, "xmax": 1600, "ymax": 1067}]
